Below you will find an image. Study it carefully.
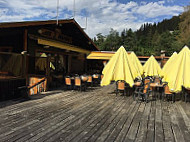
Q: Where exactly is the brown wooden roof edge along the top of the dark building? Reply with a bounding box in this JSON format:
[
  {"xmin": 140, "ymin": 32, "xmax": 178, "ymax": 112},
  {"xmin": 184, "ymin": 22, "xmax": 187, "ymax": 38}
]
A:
[{"xmin": 0, "ymin": 19, "xmax": 99, "ymax": 51}]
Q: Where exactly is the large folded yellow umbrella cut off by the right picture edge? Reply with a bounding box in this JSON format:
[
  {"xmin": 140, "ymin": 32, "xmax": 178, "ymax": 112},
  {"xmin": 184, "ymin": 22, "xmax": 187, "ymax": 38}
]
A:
[{"xmin": 164, "ymin": 46, "xmax": 190, "ymax": 93}]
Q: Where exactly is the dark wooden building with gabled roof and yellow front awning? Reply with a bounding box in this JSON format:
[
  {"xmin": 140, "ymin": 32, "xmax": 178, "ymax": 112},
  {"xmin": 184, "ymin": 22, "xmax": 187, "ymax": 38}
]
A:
[{"xmin": 0, "ymin": 19, "xmax": 98, "ymax": 98}]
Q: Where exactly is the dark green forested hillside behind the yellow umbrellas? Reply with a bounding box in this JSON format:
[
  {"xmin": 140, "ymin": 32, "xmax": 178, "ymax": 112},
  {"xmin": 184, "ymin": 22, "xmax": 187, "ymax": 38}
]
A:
[{"xmin": 93, "ymin": 6, "xmax": 190, "ymax": 56}]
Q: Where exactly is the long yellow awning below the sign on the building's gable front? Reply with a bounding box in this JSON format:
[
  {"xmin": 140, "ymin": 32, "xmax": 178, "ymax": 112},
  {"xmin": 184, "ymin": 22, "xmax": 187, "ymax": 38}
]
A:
[{"xmin": 38, "ymin": 38, "xmax": 90, "ymax": 54}]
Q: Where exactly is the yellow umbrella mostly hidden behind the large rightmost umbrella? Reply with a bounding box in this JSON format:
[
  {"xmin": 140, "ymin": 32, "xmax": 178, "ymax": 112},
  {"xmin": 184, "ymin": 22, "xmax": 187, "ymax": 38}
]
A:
[{"xmin": 161, "ymin": 52, "xmax": 177, "ymax": 76}]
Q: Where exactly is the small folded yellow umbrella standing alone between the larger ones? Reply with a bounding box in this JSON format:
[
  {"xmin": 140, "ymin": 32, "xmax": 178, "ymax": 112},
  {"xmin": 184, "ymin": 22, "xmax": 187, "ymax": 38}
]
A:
[{"xmin": 143, "ymin": 55, "xmax": 161, "ymax": 76}]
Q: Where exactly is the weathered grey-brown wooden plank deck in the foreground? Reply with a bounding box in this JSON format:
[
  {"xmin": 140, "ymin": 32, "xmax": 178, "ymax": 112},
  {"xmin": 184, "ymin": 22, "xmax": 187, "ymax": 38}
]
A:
[{"xmin": 0, "ymin": 84, "xmax": 190, "ymax": 142}]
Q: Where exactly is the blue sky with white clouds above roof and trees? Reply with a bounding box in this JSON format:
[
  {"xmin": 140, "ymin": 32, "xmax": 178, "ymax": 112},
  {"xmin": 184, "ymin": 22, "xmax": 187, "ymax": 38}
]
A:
[{"xmin": 0, "ymin": 0, "xmax": 190, "ymax": 38}]
